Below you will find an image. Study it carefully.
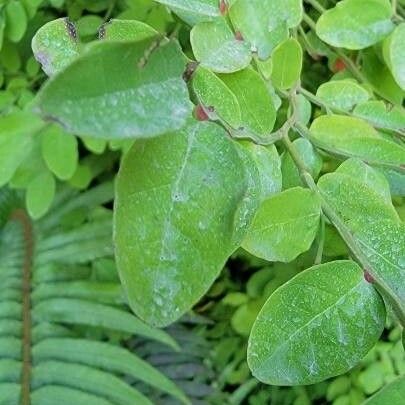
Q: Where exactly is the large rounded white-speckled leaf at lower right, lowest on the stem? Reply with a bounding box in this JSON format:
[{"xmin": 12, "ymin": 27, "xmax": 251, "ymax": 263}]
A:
[{"xmin": 248, "ymin": 261, "xmax": 385, "ymax": 385}]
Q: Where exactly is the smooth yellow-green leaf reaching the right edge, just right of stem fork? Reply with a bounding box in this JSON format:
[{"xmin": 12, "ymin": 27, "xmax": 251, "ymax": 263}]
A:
[{"xmin": 310, "ymin": 115, "xmax": 405, "ymax": 166}]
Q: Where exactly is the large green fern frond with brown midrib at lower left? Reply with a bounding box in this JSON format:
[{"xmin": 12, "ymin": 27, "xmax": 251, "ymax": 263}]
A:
[{"xmin": 0, "ymin": 183, "xmax": 189, "ymax": 405}]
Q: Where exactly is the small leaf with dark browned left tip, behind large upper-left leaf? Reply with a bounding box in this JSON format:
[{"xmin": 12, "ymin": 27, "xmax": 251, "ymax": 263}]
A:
[{"xmin": 99, "ymin": 19, "xmax": 158, "ymax": 41}]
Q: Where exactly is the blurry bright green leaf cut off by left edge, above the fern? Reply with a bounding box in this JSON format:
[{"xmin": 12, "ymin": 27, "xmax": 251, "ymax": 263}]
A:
[{"xmin": 0, "ymin": 111, "xmax": 43, "ymax": 186}]
